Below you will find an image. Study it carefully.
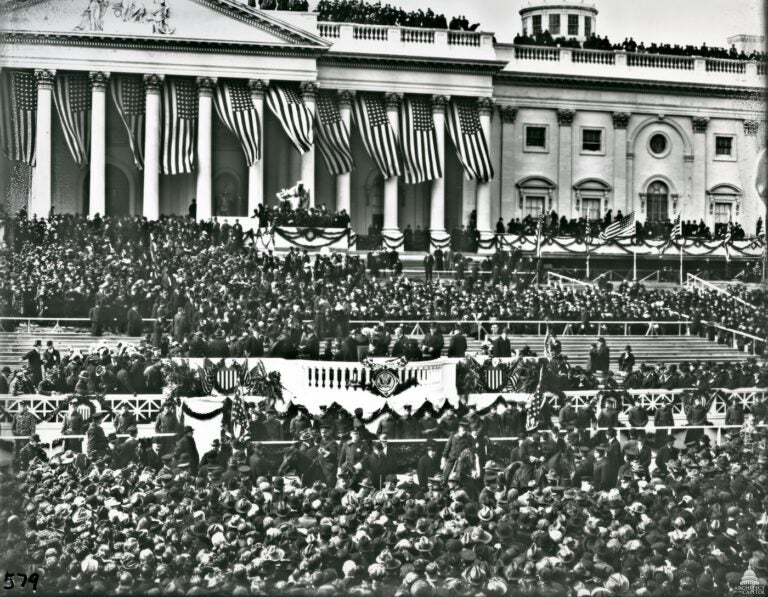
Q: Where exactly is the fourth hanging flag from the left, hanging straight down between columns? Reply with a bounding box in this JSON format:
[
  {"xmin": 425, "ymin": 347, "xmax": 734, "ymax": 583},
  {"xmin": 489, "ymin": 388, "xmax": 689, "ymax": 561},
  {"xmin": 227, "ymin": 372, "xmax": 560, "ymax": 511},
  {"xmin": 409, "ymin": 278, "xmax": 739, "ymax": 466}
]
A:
[{"xmin": 161, "ymin": 78, "xmax": 198, "ymax": 174}]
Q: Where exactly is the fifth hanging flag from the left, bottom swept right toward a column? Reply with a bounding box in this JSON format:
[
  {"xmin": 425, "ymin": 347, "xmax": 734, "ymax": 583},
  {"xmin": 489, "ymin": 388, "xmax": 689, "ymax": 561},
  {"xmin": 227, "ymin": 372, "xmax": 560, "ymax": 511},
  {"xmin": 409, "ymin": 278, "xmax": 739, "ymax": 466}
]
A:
[{"xmin": 213, "ymin": 81, "xmax": 261, "ymax": 166}]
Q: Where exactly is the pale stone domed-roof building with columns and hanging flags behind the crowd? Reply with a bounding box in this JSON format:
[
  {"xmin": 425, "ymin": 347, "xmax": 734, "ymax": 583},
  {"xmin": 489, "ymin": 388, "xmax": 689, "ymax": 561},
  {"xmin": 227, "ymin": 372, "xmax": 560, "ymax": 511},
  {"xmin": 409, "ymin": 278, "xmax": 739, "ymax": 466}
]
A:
[{"xmin": 0, "ymin": 0, "xmax": 765, "ymax": 240}]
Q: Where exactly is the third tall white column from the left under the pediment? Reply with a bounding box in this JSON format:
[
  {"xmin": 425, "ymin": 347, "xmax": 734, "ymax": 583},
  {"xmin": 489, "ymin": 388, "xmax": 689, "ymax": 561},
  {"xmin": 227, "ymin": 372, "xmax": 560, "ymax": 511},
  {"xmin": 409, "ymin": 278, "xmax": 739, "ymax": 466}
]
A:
[{"xmin": 143, "ymin": 75, "xmax": 163, "ymax": 220}]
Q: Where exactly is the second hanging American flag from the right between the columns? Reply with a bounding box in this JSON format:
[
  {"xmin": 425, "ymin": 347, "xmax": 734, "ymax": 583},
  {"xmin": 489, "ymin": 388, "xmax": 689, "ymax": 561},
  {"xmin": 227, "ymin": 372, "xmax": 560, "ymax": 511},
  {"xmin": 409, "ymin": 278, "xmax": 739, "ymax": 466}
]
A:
[{"xmin": 400, "ymin": 96, "xmax": 443, "ymax": 184}]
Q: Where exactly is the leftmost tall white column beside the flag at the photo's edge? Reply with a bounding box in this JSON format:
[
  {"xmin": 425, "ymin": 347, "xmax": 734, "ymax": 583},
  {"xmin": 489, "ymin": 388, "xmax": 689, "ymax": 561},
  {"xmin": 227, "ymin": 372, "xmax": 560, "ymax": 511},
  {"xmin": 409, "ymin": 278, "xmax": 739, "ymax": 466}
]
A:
[{"xmin": 27, "ymin": 70, "xmax": 56, "ymax": 219}]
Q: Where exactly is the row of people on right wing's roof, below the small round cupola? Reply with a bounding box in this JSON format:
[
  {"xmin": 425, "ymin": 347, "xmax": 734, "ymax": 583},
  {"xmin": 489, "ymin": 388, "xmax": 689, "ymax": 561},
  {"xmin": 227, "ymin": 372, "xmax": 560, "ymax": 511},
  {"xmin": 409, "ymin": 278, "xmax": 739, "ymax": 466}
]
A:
[{"xmin": 514, "ymin": 29, "xmax": 766, "ymax": 62}]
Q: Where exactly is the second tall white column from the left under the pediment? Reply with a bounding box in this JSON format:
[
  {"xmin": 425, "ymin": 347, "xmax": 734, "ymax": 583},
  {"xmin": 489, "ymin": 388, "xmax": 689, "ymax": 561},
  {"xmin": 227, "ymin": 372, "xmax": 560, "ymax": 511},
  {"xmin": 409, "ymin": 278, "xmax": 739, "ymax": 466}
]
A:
[{"xmin": 88, "ymin": 72, "xmax": 109, "ymax": 217}]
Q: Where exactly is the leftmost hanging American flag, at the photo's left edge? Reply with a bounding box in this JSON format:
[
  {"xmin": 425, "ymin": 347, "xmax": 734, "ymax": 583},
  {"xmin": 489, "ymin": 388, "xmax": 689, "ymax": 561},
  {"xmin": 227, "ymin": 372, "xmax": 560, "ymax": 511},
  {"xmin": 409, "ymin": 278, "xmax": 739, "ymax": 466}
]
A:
[{"xmin": 0, "ymin": 70, "xmax": 37, "ymax": 166}]
